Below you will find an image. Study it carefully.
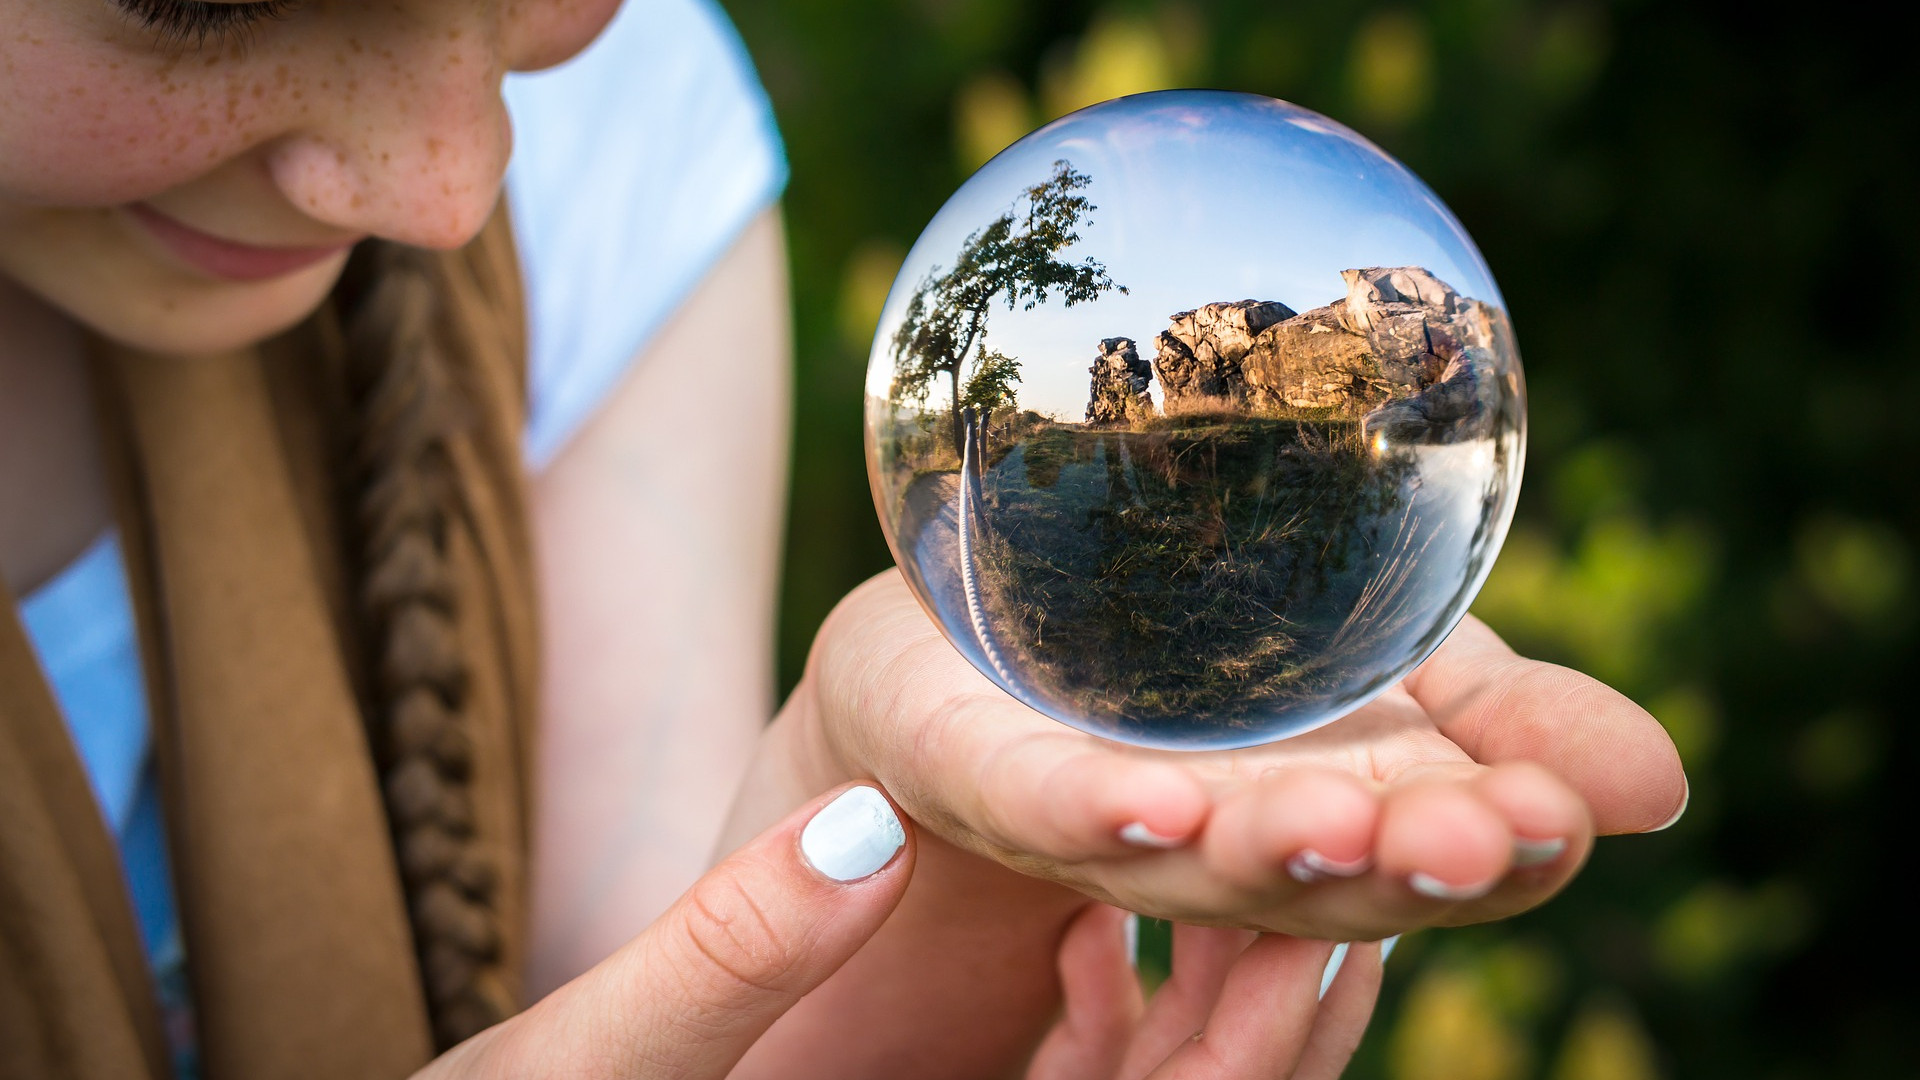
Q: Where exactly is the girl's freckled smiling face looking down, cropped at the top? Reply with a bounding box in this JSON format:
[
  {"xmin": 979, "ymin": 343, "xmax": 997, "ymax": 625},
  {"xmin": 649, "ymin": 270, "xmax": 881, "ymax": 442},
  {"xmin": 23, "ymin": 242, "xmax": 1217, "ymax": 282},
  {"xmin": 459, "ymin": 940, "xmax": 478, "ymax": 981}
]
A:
[{"xmin": 0, "ymin": 0, "xmax": 618, "ymax": 354}]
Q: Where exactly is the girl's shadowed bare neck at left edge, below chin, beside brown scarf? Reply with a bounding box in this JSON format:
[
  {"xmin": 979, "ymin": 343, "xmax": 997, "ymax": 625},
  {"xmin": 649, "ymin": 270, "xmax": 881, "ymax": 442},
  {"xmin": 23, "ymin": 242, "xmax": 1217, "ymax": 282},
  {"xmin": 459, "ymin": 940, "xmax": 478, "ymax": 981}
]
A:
[{"xmin": 0, "ymin": 275, "xmax": 111, "ymax": 596}]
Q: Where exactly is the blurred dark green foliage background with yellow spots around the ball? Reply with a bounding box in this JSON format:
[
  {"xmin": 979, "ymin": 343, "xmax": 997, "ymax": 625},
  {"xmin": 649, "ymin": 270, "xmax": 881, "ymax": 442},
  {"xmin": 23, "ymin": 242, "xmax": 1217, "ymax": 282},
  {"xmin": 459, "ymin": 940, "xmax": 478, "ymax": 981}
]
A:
[{"xmin": 726, "ymin": 0, "xmax": 1920, "ymax": 1080}]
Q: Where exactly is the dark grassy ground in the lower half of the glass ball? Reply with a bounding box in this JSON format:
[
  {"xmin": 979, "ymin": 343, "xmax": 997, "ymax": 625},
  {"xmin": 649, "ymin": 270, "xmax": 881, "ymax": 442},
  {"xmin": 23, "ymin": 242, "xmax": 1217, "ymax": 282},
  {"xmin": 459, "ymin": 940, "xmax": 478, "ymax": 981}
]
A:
[{"xmin": 977, "ymin": 413, "xmax": 1419, "ymax": 738}]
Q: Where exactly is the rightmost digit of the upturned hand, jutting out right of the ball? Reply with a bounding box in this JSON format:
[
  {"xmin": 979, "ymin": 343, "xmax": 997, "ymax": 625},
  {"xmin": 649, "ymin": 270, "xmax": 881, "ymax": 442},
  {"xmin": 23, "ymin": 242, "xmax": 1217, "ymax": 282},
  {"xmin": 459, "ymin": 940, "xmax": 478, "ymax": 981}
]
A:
[{"xmin": 1405, "ymin": 615, "xmax": 1688, "ymax": 834}]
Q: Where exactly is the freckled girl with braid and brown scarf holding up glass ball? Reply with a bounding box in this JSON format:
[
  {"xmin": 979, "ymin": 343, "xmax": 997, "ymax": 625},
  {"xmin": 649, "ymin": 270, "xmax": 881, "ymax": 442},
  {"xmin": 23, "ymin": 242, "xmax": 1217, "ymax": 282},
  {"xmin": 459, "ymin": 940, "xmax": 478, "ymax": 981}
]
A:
[{"xmin": 0, "ymin": 0, "xmax": 1686, "ymax": 1078}]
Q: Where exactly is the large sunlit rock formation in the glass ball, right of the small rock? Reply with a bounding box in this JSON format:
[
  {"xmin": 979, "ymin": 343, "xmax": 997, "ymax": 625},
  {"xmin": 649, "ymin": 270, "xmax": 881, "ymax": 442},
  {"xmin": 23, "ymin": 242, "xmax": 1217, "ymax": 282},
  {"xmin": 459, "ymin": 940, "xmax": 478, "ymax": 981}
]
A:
[{"xmin": 1144, "ymin": 267, "xmax": 1500, "ymax": 442}]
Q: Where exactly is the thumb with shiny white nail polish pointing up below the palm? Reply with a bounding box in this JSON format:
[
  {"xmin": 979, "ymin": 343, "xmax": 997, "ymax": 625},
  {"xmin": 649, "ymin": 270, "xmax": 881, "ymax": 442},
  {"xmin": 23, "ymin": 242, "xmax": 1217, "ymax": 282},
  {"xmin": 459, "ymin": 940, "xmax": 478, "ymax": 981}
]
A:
[{"xmin": 432, "ymin": 784, "xmax": 914, "ymax": 1080}]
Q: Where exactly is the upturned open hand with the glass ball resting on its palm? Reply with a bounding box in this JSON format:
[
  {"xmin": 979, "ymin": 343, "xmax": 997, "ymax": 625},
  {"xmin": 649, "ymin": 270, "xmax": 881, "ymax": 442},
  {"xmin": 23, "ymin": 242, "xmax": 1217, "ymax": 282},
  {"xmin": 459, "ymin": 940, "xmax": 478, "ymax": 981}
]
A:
[{"xmin": 781, "ymin": 573, "xmax": 1688, "ymax": 940}]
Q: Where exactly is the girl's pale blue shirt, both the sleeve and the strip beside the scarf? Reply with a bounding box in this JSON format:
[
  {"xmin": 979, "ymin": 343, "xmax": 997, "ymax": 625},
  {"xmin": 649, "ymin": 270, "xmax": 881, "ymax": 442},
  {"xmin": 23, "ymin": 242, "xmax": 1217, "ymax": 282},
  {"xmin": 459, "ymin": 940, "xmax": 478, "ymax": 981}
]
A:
[{"xmin": 21, "ymin": 0, "xmax": 787, "ymax": 997}]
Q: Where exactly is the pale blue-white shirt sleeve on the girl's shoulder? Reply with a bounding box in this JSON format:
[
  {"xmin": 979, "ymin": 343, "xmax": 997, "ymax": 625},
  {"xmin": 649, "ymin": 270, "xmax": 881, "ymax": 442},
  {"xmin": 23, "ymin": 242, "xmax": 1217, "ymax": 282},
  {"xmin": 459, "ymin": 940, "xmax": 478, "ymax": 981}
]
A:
[{"xmin": 505, "ymin": 0, "xmax": 787, "ymax": 471}]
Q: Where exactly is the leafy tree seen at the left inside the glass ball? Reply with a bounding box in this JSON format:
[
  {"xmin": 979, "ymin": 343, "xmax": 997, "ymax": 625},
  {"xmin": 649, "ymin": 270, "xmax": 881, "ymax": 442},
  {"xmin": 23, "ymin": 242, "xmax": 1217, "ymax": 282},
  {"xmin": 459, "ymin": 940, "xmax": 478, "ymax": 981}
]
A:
[{"xmin": 893, "ymin": 160, "xmax": 1127, "ymax": 450}]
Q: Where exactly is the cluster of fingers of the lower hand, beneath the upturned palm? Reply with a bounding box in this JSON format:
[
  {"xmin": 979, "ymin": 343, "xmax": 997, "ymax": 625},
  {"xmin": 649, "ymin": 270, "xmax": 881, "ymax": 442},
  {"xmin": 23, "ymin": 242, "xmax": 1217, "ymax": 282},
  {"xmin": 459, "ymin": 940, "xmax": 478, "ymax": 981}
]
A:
[{"xmin": 1027, "ymin": 903, "xmax": 1380, "ymax": 1080}]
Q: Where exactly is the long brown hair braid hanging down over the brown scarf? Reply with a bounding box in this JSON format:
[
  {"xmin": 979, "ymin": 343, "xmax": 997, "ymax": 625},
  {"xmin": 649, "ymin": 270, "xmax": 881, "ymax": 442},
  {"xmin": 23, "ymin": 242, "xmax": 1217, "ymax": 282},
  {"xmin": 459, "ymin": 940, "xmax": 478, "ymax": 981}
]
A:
[{"xmin": 344, "ymin": 242, "xmax": 515, "ymax": 1049}]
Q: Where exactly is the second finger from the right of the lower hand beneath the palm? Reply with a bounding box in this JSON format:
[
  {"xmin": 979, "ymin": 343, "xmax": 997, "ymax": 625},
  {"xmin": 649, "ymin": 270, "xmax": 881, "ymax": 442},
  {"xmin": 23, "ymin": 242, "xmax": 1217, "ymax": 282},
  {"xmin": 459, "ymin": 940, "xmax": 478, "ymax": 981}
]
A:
[{"xmin": 1150, "ymin": 934, "xmax": 1338, "ymax": 1080}]
